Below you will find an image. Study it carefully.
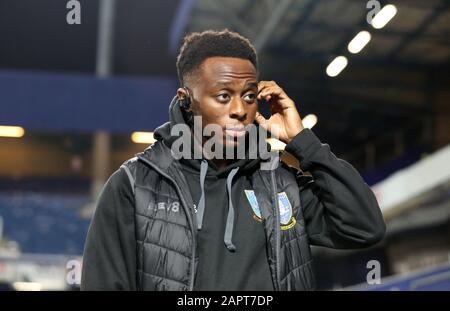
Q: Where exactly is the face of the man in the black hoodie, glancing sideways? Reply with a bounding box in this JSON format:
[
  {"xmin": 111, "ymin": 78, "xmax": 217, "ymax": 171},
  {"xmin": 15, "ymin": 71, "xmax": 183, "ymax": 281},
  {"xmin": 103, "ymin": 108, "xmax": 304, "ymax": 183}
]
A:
[{"xmin": 185, "ymin": 57, "xmax": 258, "ymax": 147}]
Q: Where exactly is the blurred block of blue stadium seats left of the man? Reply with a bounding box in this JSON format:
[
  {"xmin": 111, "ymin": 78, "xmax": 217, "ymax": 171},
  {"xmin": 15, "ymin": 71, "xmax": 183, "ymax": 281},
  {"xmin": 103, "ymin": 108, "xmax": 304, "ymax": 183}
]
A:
[{"xmin": 0, "ymin": 192, "xmax": 89, "ymax": 255}]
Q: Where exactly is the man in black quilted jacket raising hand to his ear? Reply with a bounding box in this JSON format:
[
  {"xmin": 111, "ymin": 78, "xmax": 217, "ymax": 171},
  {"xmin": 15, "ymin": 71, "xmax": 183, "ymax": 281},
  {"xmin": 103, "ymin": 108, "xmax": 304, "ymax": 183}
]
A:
[{"xmin": 81, "ymin": 30, "xmax": 385, "ymax": 290}]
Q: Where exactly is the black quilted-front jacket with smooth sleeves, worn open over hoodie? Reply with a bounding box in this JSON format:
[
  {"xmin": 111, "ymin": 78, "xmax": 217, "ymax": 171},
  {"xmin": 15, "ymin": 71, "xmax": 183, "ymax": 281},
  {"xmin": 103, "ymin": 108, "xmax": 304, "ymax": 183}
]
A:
[{"xmin": 81, "ymin": 96, "xmax": 385, "ymax": 290}]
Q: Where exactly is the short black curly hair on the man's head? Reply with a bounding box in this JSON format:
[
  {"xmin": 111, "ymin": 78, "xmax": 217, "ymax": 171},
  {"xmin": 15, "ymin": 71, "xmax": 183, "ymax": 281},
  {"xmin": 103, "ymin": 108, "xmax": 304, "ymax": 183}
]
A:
[{"xmin": 177, "ymin": 29, "xmax": 258, "ymax": 85}]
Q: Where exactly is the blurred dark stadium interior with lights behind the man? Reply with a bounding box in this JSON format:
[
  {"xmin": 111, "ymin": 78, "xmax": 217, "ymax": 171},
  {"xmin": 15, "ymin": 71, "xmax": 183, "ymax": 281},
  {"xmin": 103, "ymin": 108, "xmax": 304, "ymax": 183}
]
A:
[{"xmin": 0, "ymin": 0, "xmax": 450, "ymax": 290}]
